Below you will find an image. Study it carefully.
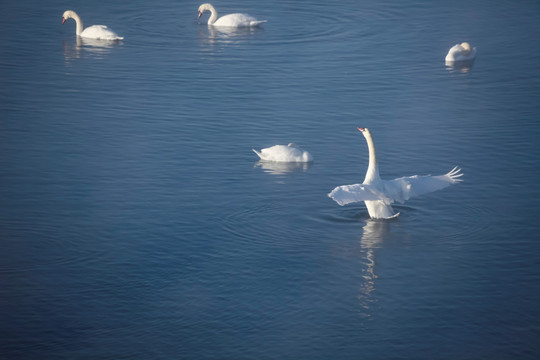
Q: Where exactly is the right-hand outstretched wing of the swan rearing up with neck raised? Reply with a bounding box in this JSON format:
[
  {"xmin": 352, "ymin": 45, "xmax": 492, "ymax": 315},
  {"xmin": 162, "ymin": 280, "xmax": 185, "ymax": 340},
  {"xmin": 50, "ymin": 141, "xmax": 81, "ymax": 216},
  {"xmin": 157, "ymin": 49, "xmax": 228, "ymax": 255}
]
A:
[{"xmin": 384, "ymin": 166, "xmax": 463, "ymax": 202}]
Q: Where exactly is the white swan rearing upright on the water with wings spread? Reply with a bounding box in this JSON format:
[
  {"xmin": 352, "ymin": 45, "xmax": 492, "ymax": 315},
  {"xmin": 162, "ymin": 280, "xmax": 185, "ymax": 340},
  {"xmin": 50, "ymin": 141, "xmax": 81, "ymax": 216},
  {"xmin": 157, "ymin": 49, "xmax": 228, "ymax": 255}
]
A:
[{"xmin": 328, "ymin": 128, "xmax": 463, "ymax": 219}]
